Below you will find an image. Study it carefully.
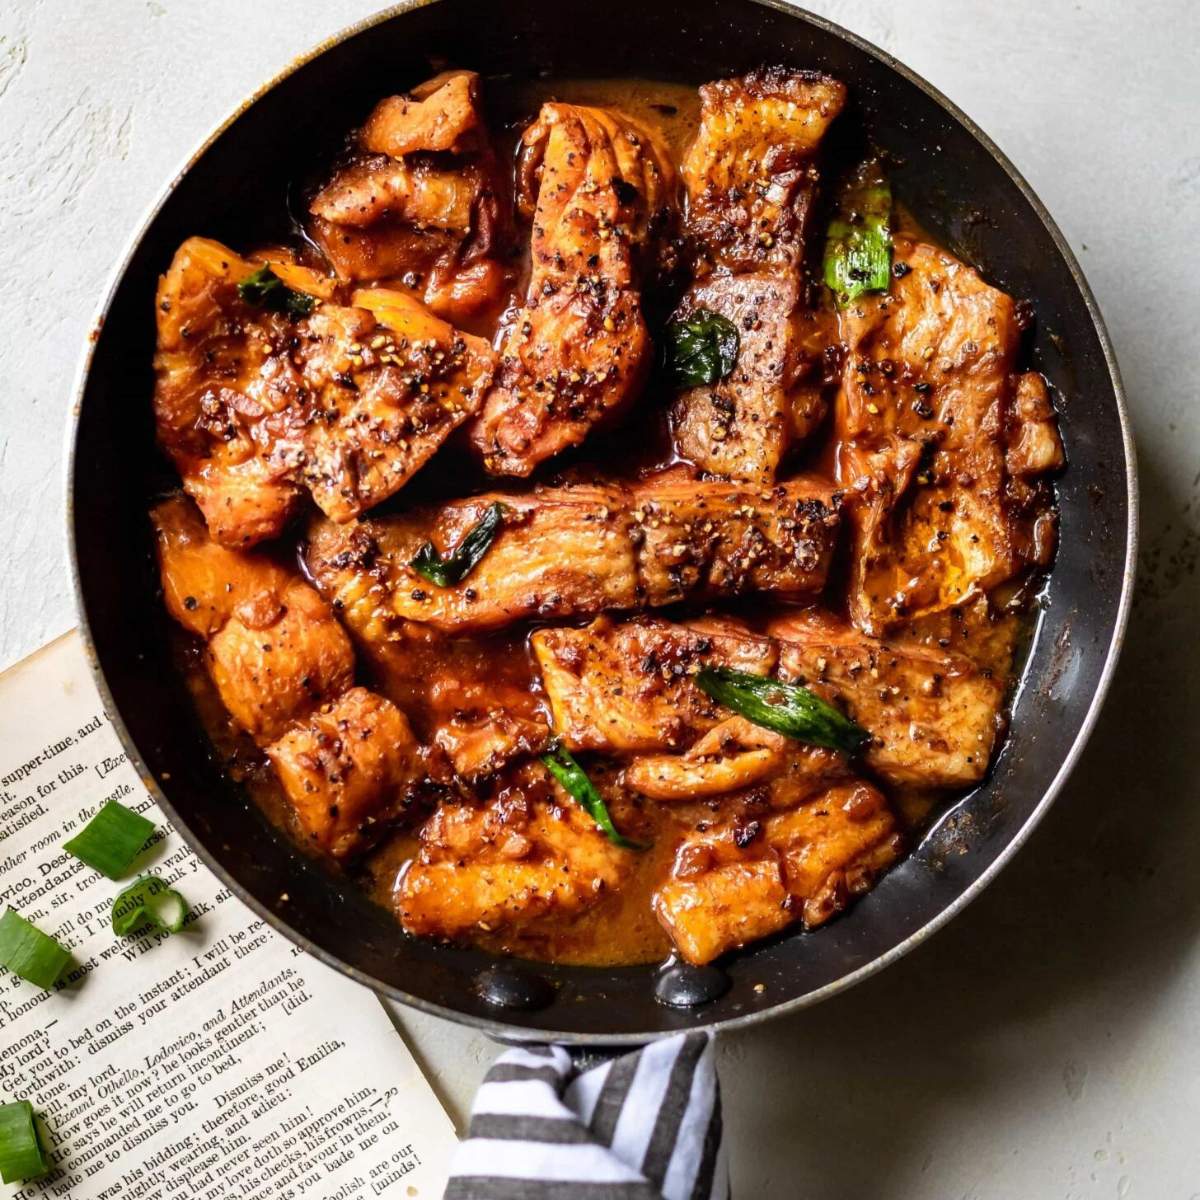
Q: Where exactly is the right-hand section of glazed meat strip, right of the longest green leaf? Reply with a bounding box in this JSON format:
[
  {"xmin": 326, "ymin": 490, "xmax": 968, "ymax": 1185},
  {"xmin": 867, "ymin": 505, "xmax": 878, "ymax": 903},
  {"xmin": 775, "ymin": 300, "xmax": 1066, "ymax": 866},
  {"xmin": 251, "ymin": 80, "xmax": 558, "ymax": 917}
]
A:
[{"xmin": 768, "ymin": 611, "xmax": 1004, "ymax": 787}]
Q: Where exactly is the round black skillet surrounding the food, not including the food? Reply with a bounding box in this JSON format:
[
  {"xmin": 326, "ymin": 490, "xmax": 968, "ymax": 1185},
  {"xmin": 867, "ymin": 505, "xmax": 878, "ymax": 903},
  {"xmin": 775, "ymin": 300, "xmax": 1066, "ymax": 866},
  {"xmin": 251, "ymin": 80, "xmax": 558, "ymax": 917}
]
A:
[{"xmin": 68, "ymin": 0, "xmax": 1136, "ymax": 1045}]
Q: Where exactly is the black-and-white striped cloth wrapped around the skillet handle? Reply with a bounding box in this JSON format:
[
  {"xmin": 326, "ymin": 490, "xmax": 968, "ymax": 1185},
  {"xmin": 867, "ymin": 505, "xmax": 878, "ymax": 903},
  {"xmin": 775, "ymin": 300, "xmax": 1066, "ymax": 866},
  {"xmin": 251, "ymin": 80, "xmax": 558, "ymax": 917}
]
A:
[{"xmin": 445, "ymin": 1033, "xmax": 730, "ymax": 1200}]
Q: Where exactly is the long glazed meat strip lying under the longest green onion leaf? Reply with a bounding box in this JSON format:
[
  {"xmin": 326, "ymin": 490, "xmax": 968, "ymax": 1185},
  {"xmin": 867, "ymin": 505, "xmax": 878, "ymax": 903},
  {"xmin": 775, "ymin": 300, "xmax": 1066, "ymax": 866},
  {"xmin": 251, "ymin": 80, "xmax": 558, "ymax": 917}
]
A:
[{"xmin": 530, "ymin": 611, "xmax": 1004, "ymax": 800}]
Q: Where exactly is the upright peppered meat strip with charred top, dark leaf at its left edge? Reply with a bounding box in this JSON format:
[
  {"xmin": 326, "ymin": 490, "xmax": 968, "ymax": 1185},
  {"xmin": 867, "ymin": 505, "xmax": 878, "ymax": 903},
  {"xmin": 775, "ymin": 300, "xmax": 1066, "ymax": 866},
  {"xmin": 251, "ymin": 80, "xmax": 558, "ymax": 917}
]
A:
[{"xmin": 673, "ymin": 68, "xmax": 846, "ymax": 484}]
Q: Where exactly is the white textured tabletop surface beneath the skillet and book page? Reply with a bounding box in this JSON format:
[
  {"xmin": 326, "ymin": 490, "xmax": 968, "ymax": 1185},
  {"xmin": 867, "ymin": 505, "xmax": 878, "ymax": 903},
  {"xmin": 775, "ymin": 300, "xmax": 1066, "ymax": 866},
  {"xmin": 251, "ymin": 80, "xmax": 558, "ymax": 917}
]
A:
[{"xmin": 0, "ymin": 0, "xmax": 1200, "ymax": 1200}]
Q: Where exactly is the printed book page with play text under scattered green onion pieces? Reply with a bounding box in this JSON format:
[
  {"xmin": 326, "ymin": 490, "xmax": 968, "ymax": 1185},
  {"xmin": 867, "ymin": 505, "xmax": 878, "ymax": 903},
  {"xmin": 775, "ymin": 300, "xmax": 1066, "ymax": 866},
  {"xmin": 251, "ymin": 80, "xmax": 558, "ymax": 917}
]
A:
[{"xmin": 0, "ymin": 634, "xmax": 455, "ymax": 1200}]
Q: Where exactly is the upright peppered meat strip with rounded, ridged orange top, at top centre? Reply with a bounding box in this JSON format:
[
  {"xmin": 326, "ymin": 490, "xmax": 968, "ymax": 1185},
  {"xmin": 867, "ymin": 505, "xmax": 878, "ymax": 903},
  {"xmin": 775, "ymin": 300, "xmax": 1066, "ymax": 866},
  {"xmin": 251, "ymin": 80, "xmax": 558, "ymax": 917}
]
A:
[{"xmin": 472, "ymin": 104, "xmax": 676, "ymax": 475}]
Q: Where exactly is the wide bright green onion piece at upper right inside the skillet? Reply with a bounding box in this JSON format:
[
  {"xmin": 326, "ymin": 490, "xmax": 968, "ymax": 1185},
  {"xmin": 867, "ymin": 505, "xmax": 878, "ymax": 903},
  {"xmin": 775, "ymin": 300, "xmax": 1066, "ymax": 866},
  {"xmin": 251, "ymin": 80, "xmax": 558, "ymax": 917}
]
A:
[{"xmin": 824, "ymin": 162, "xmax": 892, "ymax": 307}]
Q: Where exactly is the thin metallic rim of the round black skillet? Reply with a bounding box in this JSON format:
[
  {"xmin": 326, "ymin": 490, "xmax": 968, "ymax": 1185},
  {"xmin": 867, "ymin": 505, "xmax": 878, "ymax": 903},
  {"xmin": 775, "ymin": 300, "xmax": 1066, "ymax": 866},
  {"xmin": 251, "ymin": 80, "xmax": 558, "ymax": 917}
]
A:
[{"xmin": 64, "ymin": 0, "xmax": 1139, "ymax": 1046}]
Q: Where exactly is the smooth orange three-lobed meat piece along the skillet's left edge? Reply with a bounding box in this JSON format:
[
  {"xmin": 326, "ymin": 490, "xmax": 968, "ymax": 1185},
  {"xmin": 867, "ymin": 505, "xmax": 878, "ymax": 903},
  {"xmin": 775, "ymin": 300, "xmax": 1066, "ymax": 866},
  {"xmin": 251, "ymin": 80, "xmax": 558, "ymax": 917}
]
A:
[{"xmin": 150, "ymin": 497, "xmax": 426, "ymax": 857}]
